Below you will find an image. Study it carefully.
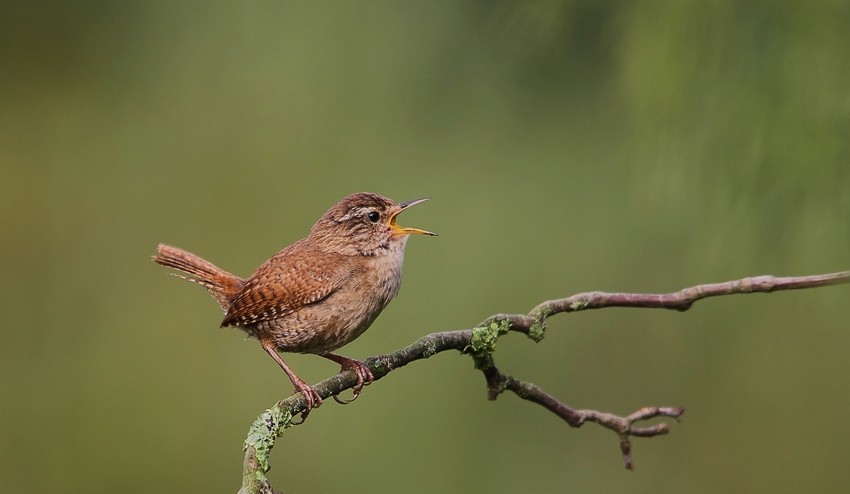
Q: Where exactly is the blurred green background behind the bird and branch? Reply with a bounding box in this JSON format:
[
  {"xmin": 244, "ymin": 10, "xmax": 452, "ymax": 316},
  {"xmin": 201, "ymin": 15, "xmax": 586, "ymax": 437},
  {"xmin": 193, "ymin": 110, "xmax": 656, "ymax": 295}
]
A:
[{"xmin": 0, "ymin": 0, "xmax": 850, "ymax": 493}]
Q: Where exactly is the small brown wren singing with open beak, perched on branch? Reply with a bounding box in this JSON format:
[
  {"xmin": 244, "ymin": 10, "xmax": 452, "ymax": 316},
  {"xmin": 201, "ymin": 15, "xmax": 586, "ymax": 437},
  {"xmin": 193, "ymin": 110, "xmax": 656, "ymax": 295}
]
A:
[{"xmin": 153, "ymin": 192, "xmax": 436, "ymax": 416}]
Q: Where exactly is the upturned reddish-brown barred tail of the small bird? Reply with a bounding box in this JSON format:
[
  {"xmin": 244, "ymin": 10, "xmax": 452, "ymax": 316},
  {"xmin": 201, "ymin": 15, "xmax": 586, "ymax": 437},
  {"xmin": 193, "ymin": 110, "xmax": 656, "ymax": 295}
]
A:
[{"xmin": 153, "ymin": 244, "xmax": 245, "ymax": 312}]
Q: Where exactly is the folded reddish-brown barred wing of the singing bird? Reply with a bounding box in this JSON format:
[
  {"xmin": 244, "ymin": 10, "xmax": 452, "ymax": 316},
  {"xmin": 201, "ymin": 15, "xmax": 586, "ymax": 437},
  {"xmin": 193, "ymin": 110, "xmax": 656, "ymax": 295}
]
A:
[{"xmin": 221, "ymin": 244, "xmax": 347, "ymax": 327}]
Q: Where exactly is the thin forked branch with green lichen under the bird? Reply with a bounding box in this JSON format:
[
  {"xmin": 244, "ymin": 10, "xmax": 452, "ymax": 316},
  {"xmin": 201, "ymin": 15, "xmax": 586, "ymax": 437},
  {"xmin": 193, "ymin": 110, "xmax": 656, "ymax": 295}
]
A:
[{"xmin": 239, "ymin": 271, "xmax": 850, "ymax": 494}]
